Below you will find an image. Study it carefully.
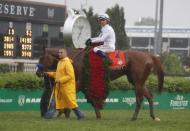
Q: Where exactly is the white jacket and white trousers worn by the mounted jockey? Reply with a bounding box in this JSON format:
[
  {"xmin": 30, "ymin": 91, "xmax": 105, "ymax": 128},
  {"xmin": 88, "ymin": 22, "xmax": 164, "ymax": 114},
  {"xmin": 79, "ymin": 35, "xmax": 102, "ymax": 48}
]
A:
[{"xmin": 91, "ymin": 24, "xmax": 115, "ymax": 52}]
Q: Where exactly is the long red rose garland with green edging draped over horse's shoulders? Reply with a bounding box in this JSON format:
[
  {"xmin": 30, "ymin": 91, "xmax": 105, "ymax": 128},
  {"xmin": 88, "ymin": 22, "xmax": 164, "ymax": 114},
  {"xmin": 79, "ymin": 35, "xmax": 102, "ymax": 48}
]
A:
[{"xmin": 83, "ymin": 50, "xmax": 109, "ymax": 109}]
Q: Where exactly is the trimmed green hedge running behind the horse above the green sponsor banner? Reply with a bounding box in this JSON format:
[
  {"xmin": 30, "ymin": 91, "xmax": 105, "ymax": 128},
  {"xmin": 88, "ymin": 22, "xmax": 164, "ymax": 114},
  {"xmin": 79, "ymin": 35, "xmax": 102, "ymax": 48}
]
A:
[{"xmin": 0, "ymin": 73, "xmax": 190, "ymax": 92}]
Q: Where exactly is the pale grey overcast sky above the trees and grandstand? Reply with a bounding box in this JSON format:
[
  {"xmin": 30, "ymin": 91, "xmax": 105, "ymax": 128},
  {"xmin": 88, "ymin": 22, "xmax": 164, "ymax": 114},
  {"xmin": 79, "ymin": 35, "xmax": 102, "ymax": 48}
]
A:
[{"xmin": 33, "ymin": 0, "xmax": 190, "ymax": 28}]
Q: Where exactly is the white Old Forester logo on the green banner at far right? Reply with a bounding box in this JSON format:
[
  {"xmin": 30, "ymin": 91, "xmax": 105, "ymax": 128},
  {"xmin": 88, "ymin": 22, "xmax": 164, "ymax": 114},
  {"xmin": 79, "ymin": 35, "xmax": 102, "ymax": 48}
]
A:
[{"xmin": 170, "ymin": 95, "xmax": 188, "ymax": 109}]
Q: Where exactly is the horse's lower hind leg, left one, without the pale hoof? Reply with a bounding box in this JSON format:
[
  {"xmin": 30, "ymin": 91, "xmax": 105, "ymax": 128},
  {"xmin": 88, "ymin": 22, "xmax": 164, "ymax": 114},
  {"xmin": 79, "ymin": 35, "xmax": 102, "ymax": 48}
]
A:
[{"xmin": 131, "ymin": 87, "xmax": 143, "ymax": 121}]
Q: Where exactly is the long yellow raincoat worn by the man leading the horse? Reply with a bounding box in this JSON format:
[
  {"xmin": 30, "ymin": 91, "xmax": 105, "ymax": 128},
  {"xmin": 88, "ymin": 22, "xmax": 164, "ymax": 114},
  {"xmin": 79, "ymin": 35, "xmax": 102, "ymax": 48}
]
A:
[{"xmin": 47, "ymin": 57, "xmax": 78, "ymax": 109}]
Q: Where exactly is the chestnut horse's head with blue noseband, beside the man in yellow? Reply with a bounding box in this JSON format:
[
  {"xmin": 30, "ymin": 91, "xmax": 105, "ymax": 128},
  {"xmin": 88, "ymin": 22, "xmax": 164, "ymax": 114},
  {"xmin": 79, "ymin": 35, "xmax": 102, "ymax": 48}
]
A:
[{"xmin": 36, "ymin": 54, "xmax": 58, "ymax": 77}]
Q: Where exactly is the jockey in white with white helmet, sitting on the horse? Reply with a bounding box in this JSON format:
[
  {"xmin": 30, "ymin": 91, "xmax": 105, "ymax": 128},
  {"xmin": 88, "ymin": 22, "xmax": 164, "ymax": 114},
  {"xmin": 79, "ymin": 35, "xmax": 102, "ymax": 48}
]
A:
[{"xmin": 86, "ymin": 14, "xmax": 116, "ymax": 61}]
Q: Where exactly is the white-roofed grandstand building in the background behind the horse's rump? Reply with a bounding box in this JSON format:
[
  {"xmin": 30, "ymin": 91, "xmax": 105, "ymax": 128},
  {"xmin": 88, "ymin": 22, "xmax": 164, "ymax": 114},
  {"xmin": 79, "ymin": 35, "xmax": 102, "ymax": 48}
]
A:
[{"xmin": 126, "ymin": 26, "xmax": 190, "ymax": 56}]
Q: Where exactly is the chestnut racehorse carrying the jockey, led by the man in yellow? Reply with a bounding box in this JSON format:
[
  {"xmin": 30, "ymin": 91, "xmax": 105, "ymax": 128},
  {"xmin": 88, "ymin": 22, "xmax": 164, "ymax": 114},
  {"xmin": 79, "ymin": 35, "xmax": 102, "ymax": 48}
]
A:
[{"xmin": 36, "ymin": 48, "xmax": 164, "ymax": 120}]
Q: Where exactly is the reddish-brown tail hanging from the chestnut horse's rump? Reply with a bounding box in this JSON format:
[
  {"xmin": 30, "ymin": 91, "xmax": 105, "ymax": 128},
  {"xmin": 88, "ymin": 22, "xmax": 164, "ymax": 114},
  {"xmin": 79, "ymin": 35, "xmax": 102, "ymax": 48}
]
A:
[{"xmin": 152, "ymin": 56, "xmax": 164, "ymax": 92}]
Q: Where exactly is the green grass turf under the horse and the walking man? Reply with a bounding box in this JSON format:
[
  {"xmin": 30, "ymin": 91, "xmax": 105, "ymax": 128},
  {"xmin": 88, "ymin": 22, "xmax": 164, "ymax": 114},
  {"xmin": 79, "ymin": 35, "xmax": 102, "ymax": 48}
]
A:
[{"xmin": 0, "ymin": 109, "xmax": 190, "ymax": 131}]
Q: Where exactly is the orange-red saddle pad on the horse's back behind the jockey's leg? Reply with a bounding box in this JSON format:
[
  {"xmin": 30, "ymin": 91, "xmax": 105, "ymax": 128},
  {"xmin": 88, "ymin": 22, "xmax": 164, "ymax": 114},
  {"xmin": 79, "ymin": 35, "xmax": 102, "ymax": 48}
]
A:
[{"xmin": 106, "ymin": 50, "xmax": 127, "ymax": 67}]
